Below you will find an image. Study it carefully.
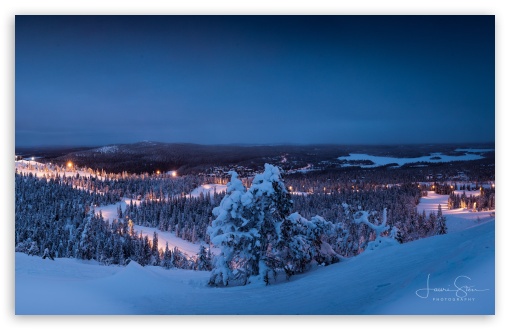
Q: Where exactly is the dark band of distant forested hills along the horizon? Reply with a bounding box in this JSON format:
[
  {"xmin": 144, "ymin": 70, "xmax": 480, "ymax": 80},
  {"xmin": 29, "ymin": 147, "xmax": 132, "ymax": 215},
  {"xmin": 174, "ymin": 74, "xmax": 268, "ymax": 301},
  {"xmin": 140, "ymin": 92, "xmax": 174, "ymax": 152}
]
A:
[{"xmin": 16, "ymin": 141, "xmax": 494, "ymax": 174}]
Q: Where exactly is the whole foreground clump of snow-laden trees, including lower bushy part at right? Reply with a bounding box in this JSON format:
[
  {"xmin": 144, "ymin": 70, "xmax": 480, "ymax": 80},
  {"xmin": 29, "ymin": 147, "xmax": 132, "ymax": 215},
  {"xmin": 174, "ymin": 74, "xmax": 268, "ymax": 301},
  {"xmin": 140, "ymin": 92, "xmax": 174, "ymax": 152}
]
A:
[{"xmin": 208, "ymin": 164, "xmax": 338, "ymax": 285}]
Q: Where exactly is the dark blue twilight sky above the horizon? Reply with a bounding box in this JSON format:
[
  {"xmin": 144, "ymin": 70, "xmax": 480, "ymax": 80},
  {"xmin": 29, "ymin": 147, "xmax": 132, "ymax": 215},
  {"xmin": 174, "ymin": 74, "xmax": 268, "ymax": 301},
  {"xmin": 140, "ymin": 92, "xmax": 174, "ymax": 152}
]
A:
[{"xmin": 15, "ymin": 16, "xmax": 495, "ymax": 146}]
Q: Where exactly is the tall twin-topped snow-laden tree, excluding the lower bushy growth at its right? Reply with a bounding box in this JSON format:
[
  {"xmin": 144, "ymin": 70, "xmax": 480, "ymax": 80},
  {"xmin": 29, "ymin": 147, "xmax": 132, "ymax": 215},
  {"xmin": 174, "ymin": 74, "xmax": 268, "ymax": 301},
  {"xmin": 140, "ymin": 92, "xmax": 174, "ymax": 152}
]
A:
[{"xmin": 208, "ymin": 164, "xmax": 298, "ymax": 285}]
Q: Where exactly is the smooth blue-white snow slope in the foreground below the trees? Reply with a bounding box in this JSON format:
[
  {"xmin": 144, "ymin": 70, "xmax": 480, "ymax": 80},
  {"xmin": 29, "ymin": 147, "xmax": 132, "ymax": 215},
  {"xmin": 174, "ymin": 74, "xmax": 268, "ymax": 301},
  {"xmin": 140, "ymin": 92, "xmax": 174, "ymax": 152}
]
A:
[{"xmin": 15, "ymin": 217, "xmax": 495, "ymax": 315}]
